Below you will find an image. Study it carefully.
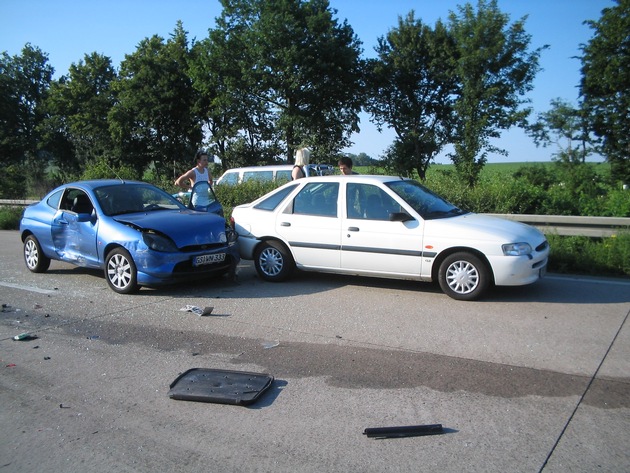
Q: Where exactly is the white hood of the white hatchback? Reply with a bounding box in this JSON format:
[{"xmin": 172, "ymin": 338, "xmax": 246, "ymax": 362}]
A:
[{"xmin": 425, "ymin": 213, "xmax": 545, "ymax": 244}]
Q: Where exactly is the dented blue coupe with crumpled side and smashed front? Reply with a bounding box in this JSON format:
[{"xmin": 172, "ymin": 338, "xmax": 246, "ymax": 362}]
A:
[{"xmin": 20, "ymin": 180, "xmax": 239, "ymax": 294}]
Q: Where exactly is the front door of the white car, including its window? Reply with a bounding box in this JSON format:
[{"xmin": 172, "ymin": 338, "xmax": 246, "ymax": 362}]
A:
[{"xmin": 341, "ymin": 183, "xmax": 423, "ymax": 277}]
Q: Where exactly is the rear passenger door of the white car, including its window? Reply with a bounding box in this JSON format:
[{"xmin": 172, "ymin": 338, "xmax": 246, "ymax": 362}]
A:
[{"xmin": 276, "ymin": 182, "xmax": 341, "ymax": 269}]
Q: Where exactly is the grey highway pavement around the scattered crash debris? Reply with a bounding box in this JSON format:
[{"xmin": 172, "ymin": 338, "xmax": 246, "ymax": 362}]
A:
[{"xmin": 0, "ymin": 231, "xmax": 630, "ymax": 473}]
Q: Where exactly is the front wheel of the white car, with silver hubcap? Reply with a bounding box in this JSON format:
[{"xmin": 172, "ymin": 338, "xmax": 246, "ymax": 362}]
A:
[{"xmin": 438, "ymin": 252, "xmax": 490, "ymax": 301}]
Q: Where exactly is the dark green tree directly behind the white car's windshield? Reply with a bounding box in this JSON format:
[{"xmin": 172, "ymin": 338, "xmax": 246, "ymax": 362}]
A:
[{"xmin": 366, "ymin": 11, "xmax": 457, "ymax": 180}]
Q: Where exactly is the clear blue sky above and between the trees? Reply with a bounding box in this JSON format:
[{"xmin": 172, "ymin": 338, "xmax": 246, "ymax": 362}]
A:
[{"xmin": 0, "ymin": 0, "xmax": 616, "ymax": 163}]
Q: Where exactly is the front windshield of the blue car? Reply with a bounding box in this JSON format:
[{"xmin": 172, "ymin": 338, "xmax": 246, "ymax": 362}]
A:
[{"xmin": 94, "ymin": 184, "xmax": 186, "ymax": 216}]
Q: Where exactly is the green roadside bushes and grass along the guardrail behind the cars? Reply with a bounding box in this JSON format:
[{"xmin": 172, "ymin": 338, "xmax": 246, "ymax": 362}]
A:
[{"xmin": 0, "ymin": 163, "xmax": 630, "ymax": 277}]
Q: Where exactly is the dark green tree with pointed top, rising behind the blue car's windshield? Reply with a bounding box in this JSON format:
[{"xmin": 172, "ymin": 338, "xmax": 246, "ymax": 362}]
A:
[{"xmin": 108, "ymin": 22, "xmax": 203, "ymax": 179}]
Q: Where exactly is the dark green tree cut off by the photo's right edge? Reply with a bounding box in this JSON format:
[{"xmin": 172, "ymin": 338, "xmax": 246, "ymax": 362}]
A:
[{"xmin": 580, "ymin": 0, "xmax": 630, "ymax": 183}]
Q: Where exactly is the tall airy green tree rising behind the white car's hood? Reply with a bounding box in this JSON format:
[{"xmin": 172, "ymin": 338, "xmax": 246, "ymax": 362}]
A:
[{"xmin": 449, "ymin": 0, "xmax": 547, "ymax": 186}]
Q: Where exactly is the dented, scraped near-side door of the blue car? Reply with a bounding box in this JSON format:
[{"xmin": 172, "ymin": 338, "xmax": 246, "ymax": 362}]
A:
[{"xmin": 51, "ymin": 189, "xmax": 99, "ymax": 267}]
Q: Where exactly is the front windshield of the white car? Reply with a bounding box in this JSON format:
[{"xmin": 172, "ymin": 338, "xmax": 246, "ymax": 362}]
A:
[{"xmin": 385, "ymin": 180, "xmax": 468, "ymax": 220}]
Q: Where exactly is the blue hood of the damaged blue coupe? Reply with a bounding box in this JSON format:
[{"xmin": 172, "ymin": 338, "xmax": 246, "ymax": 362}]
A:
[{"xmin": 114, "ymin": 210, "xmax": 225, "ymax": 248}]
